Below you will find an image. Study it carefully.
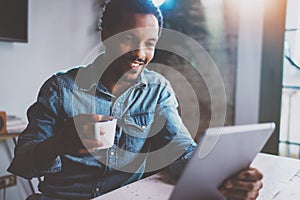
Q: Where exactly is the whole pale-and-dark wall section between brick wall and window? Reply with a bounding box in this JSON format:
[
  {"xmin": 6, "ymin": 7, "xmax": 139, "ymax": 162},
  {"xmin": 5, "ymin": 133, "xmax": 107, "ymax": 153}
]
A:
[{"xmin": 235, "ymin": 0, "xmax": 287, "ymax": 154}]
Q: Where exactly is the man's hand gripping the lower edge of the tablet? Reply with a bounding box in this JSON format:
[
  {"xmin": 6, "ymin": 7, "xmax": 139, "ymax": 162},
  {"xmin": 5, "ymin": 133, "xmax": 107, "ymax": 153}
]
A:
[{"xmin": 219, "ymin": 168, "xmax": 263, "ymax": 200}]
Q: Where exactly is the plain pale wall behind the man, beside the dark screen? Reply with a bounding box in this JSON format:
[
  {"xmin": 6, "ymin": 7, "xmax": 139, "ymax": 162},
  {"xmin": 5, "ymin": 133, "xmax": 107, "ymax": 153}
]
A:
[{"xmin": 0, "ymin": 0, "xmax": 100, "ymax": 200}]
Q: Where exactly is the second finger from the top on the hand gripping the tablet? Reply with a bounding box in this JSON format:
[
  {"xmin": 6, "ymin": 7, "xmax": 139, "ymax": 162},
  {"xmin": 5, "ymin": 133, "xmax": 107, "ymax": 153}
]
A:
[{"xmin": 223, "ymin": 180, "xmax": 263, "ymax": 191}]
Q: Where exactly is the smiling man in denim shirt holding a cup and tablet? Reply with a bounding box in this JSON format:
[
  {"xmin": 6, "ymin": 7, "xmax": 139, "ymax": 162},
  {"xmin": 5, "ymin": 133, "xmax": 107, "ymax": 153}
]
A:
[{"xmin": 9, "ymin": 0, "xmax": 262, "ymax": 199}]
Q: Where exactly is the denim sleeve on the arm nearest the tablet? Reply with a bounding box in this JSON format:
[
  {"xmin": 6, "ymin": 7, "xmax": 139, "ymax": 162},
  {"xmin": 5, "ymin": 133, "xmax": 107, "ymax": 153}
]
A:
[{"xmin": 148, "ymin": 79, "xmax": 196, "ymax": 176}]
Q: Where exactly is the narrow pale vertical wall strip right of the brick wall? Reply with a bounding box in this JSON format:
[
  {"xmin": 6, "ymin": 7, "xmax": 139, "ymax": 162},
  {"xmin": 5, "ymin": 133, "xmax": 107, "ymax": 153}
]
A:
[{"xmin": 235, "ymin": 0, "xmax": 264, "ymax": 124}]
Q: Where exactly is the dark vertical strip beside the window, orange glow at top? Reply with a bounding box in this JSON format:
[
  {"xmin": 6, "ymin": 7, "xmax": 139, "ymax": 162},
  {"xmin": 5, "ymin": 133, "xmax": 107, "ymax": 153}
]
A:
[{"xmin": 259, "ymin": 0, "xmax": 287, "ymax": 154}]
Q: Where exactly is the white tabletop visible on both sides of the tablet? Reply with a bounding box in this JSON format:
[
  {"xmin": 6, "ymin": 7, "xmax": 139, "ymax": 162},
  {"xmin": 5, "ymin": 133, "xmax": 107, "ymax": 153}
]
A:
[{"xmin": 94, "ymin": 153, "xmax": 300, "ymax": 200}]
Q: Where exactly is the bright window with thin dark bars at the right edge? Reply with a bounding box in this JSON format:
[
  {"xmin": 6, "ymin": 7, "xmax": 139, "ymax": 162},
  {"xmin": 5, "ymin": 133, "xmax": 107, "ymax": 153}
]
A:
[{"xmin": 279, "ymin": 0, "xmax": 300, "ymax": 158}]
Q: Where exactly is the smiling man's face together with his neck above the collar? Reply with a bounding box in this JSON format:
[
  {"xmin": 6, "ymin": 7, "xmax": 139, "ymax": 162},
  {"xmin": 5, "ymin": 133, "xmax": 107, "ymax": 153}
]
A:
[{"xmin": 102, "ymin": 10, "xmax": 160, "ymax": 95}]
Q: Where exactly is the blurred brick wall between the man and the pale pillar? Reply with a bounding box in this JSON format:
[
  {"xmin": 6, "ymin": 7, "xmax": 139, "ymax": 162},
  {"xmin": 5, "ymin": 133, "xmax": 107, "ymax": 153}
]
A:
[{"xmin": 154, "ymin": 0, "xmax": 239, "ymax": 140}]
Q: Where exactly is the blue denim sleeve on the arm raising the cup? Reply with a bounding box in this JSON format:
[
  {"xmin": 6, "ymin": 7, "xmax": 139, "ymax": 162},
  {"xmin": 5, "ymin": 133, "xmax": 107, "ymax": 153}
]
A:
[{"xmin": 8, "ymin": 76, "xmax": 62, "ymax": 179}]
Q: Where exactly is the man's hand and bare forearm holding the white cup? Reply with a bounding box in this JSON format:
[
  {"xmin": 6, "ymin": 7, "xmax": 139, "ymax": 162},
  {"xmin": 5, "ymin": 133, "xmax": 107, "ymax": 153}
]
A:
[{"xmin": 34, "ymin": 114, "xmax": 105, "ymax": 169}]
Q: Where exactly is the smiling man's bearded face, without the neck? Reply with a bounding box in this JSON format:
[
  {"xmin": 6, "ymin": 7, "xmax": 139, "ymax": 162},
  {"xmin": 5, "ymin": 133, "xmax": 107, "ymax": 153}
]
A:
[{"xmin": 105, "ymin": 11, "xmax": 159, "ymax": 82}]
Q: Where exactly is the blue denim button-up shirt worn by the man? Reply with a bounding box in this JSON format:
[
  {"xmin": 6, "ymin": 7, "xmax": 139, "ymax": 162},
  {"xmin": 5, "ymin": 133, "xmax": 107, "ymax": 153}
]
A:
[{"xmin": 8, "ymin": 55, "xmax": 196, "ymax": 199}]
